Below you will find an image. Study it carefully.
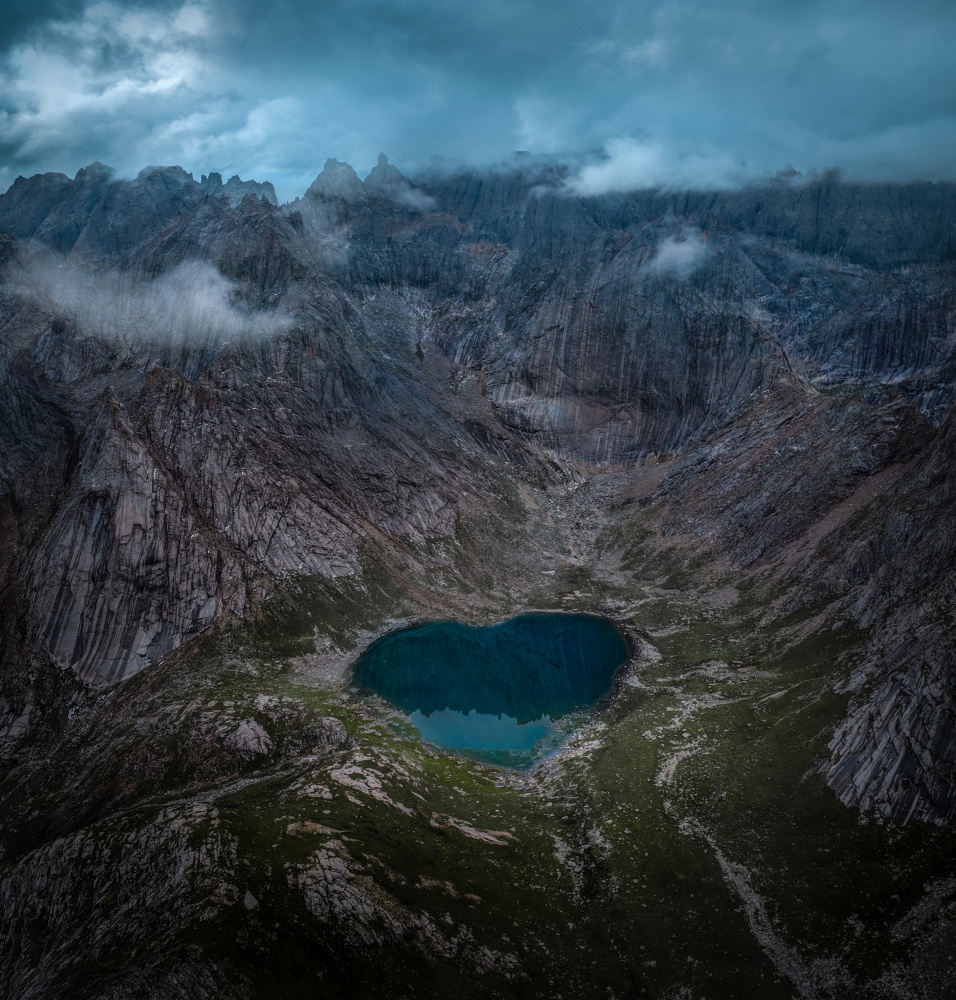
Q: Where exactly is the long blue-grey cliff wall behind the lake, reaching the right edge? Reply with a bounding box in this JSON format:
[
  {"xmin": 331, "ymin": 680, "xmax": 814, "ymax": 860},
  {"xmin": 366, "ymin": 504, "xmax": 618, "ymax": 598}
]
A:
[{"xmin": 298, "ymin": 166, "xmax": 954, "ymax": 465}]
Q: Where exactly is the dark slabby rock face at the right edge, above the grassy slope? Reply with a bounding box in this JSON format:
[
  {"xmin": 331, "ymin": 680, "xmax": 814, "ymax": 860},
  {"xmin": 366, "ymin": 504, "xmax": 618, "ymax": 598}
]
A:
[{"xmin": 823, "ymin": 407, "xmax": 956, "ymax": 823}]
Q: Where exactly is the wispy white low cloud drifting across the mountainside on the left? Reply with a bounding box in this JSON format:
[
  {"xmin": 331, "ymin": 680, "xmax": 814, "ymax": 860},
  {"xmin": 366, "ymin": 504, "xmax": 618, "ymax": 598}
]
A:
[{"xmin": 21, "ymin": 261, "xmax": 292, "ymax": 347}]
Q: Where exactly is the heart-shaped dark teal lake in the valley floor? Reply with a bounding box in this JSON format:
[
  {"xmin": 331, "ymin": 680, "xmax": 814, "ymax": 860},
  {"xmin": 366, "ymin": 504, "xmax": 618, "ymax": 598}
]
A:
[{"xmin": 354, "ymin": 612, "xmax": 628, "ymax": 769}]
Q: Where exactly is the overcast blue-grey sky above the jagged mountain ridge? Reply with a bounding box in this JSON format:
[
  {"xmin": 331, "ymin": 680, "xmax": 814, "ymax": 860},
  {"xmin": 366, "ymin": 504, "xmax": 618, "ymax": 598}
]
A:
[{"xmin": 0, "ymin": 0, "xmax": 956, "ymax": 200}]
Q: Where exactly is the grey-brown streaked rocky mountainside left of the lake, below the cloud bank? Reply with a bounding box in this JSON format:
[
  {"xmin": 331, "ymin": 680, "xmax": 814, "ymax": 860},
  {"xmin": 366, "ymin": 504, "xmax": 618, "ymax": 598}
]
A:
[{"xmin": 0, "ymin": 230, "xmax": 536, "ymax": 682}]
